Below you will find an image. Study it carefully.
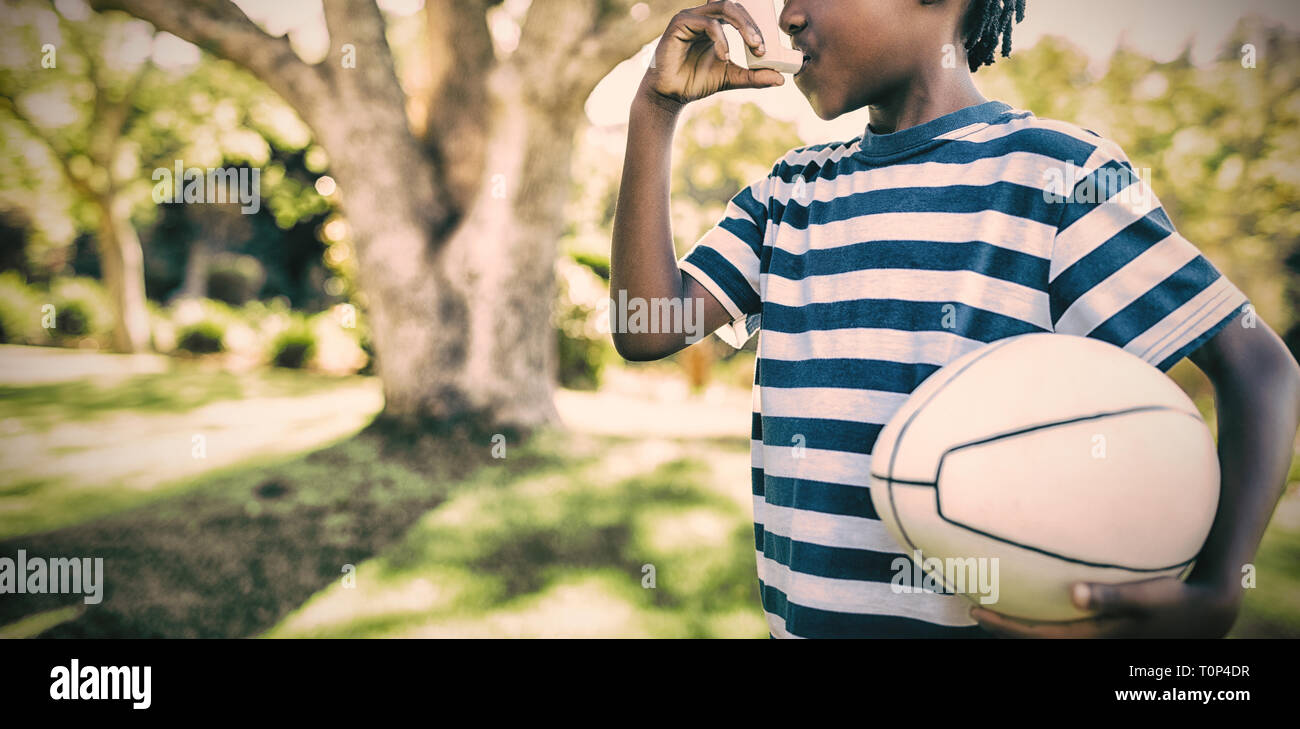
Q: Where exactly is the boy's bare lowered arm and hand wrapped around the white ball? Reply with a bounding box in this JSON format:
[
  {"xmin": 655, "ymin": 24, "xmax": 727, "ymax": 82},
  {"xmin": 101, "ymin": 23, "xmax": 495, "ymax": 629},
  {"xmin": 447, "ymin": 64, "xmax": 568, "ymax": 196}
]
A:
[{"xmin": 971, "ymin": 314, "xmax": 1300, "ymax": 638}]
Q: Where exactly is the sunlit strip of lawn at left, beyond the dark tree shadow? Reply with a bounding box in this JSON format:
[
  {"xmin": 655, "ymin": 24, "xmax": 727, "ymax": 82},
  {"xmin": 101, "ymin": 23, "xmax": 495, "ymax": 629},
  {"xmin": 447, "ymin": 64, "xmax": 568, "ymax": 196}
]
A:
[{"xmin": 0, "ymin": 347, "xmax": 384, "ymax": 538}]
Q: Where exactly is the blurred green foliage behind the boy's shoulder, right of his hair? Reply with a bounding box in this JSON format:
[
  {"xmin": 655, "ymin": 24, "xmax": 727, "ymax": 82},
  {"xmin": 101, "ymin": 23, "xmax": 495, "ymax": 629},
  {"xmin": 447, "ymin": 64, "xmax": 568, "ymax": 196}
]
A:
[{"xmin": 976, "ymin": 19, "xmax": 1300, "ymax": 352}]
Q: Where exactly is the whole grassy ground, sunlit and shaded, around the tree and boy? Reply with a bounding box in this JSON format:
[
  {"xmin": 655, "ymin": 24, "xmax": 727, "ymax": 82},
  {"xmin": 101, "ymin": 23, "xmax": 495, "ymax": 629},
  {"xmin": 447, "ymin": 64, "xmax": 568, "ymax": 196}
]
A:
[{"xmin": 0, "ymin": 352, "xmax": 1300, "ymax": 637}]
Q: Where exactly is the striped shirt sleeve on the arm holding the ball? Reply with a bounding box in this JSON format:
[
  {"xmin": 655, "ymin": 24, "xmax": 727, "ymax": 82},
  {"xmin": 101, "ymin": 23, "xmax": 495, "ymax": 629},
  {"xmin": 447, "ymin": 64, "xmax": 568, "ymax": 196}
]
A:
[{"xmin": 1048, "ymin": 140, "xmax": 1249, "ymax": 372}]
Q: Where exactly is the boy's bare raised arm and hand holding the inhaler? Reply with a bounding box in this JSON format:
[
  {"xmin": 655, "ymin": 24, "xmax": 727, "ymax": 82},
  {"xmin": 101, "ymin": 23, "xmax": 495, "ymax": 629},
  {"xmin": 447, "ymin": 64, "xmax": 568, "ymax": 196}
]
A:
[{"xmin": 610, "ymin": 3, "xmax": 784, "ymax": 360}]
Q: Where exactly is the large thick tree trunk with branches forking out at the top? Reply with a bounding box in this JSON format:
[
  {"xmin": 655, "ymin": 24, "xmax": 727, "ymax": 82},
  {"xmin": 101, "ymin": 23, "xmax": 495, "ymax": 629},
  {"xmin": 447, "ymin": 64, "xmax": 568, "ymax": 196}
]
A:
[{"xmin": 91, "ymin": 0, "xmax": 677, "ymax": 429}]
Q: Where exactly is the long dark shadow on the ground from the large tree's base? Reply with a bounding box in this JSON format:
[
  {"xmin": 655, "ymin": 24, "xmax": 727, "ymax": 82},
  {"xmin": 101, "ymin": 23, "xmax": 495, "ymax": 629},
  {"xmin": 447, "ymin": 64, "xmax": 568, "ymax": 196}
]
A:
[{"xmin": 0, "ymin": 422, "xmax": 553, "ymax": 638}]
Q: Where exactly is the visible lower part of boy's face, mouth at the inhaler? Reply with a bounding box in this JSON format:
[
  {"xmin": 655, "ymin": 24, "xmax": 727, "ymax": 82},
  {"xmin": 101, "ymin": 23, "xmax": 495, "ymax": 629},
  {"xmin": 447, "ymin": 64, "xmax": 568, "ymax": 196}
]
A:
[{"xmin": 779, "ymin": 0, "xmax": 966, "ymax": 120}]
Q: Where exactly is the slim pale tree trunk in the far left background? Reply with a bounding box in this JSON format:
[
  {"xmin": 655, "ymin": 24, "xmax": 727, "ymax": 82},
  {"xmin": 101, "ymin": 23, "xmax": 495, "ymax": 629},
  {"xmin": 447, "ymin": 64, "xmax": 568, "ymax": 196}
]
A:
[{"xmin": 95, "ymin": 195, "xmax": 150, "ymax": 353}]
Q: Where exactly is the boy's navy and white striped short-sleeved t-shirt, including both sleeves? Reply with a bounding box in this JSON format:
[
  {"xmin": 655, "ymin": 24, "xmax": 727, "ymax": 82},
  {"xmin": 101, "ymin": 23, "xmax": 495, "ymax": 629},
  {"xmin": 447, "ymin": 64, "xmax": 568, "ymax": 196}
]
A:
[{"xmin": 680, "ymin": 101, "xmax": 1247, "ymax": 638}]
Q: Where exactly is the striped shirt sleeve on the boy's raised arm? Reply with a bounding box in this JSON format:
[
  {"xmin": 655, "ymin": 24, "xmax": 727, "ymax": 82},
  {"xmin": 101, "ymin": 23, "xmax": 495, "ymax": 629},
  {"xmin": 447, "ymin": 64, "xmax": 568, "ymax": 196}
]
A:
[{"xmin": 677, "ymin": 177, "xmax": 771, "ymax": 350}]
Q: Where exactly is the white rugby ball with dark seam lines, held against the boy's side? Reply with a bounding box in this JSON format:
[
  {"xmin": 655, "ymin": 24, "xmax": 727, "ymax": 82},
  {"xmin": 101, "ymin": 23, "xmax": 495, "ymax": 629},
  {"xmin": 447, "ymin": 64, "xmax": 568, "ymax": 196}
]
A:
[{"xmin": 871, "ymin": 334, "xmax": 1219, "ymax": 621}]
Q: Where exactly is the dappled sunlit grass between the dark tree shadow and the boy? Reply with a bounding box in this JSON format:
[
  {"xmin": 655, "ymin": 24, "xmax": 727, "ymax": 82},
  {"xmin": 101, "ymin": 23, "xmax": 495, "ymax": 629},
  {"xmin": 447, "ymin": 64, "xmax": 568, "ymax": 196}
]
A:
[{"xmin": 269, "ymin": 439, "xmax": 767, "ymax": 637}]
